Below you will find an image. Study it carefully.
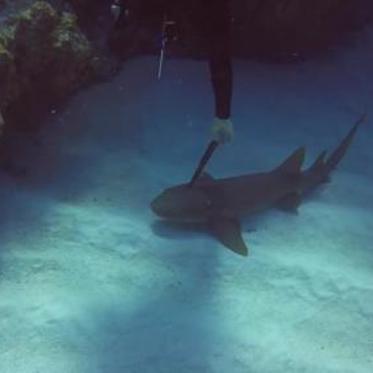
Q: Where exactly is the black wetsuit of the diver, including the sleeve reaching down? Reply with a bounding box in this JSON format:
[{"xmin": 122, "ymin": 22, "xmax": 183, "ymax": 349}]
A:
[{"xmin": 115, "ymin": 0, "xmax": 232, "ymax": 119}]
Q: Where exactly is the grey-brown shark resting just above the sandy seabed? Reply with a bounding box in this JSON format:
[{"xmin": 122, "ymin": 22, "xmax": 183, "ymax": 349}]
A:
[{"xmin": 150, "ymin": 115, "xmax": 366, "ymax": 256}]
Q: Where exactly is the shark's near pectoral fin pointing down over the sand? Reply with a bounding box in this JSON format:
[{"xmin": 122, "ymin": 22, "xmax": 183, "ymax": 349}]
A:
[{"xmin": 209, "ymin": 216, "xmax": 249, "ymax": 256}]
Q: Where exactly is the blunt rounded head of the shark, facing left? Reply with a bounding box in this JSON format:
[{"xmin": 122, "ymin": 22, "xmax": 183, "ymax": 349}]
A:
[{"xmin": 151, "ymin": 185, "xmax": 211, "ymax": 220}]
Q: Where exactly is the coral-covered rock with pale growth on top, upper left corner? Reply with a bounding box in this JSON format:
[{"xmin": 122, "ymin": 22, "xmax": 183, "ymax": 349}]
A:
[{"xmin": 0, "ymin": 1, "xmax": 97, "ymax": 134}]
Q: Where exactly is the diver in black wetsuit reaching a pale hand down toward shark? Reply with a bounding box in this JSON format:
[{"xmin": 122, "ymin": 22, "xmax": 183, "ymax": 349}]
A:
[{"xmin": 111, "ymin": 0, "xmax": 234, "ymax": 144}]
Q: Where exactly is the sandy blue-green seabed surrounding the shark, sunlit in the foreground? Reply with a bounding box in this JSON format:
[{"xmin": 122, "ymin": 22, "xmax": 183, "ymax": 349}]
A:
[{"xmin": 0, "ymin": 28, "xmax": 373, "ymax": 373}]
